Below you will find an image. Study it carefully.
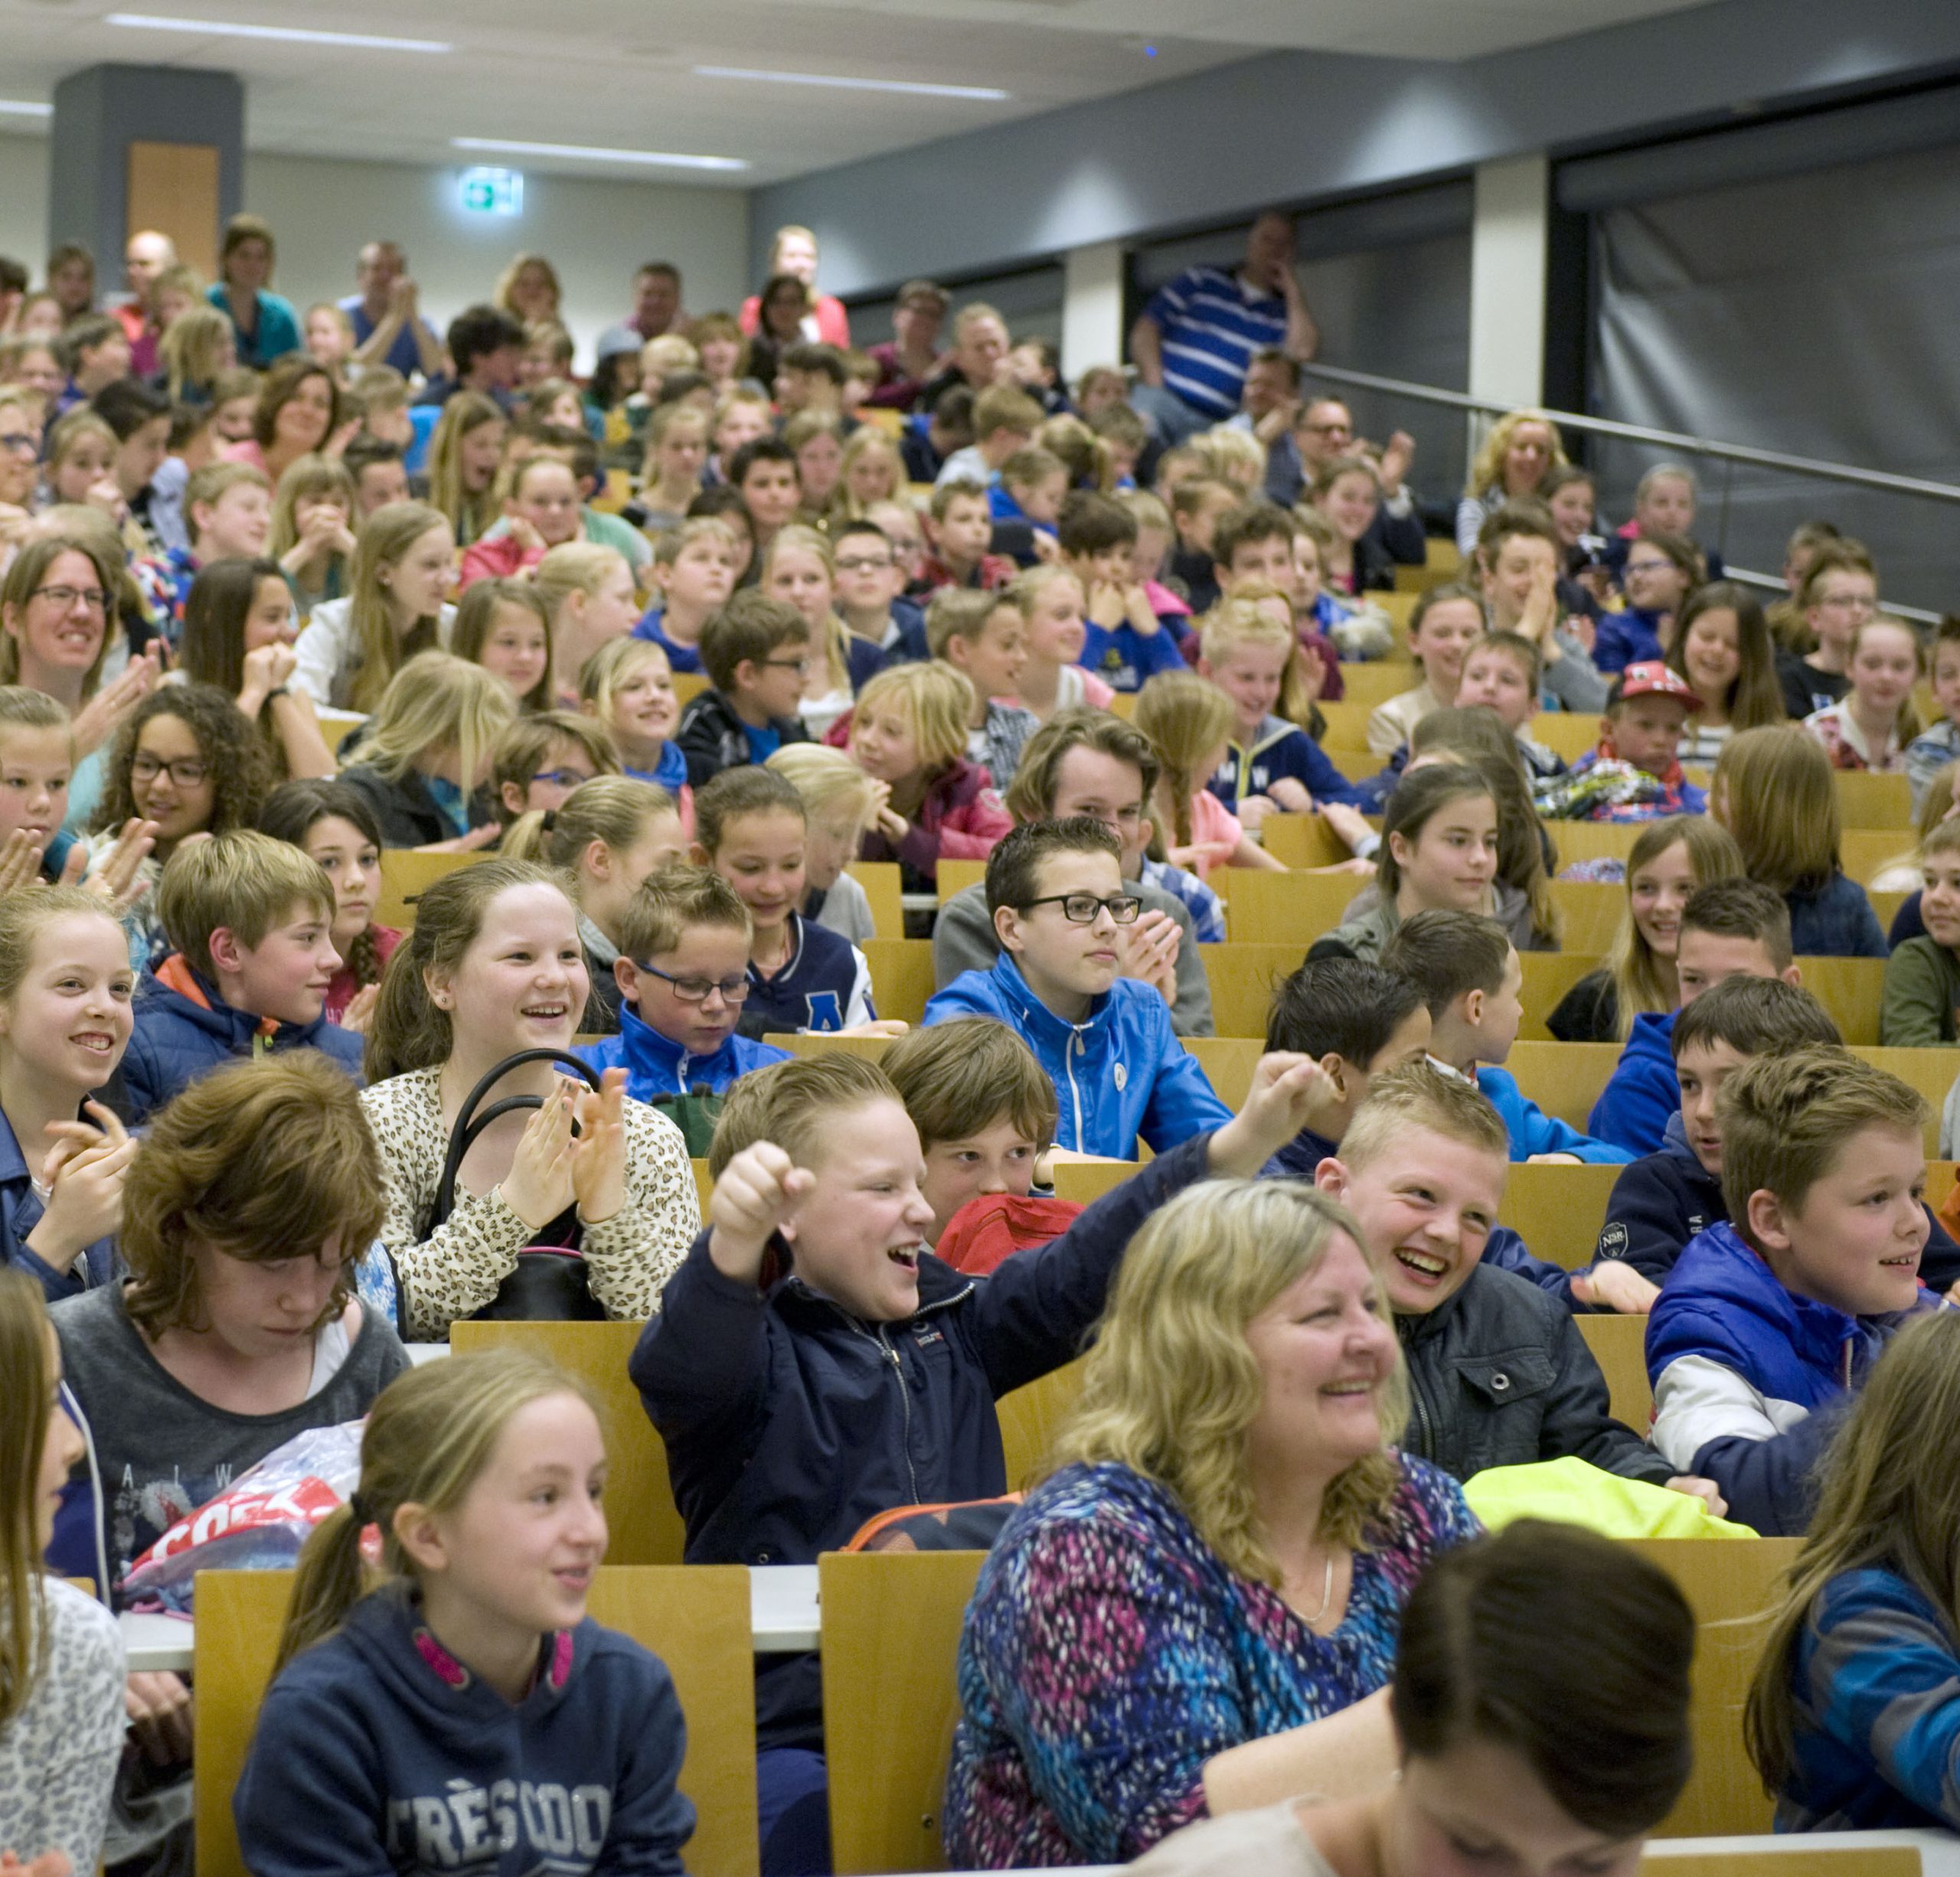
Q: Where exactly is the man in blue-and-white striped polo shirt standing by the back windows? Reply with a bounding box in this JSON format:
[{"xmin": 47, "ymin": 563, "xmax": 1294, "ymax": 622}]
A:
[{"xmin": 1129, "ymin": 210, "xmax": 1321, "ymax": 445}]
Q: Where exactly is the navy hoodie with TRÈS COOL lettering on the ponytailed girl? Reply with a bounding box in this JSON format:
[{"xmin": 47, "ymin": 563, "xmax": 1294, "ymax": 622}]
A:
[{"xmin": 231, "ymin": 1589, "xmax": 694, "ymax": 1877}]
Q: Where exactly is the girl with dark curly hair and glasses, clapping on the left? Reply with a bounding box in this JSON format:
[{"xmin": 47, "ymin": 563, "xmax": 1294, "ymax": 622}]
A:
[{"xmin": 88, "ymin": 684, "xmax": 270, "ymax": 970}]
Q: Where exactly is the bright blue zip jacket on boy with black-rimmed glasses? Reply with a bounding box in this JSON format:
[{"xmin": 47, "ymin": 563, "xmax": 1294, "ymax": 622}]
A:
[{"xmin": 925, "ymin": 952, "xmax": 1231, "ymax": 1160}]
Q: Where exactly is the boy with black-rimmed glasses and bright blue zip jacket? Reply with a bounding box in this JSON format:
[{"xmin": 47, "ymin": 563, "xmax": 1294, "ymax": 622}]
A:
[{"xmin": 925, "ymin": 815, "xmax": 1231, "ymax": 1160}]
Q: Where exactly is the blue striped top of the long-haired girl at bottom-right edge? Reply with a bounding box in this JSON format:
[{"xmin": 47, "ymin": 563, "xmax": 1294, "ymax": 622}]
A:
[{"xmin": 1775, "ymin": 1568, "xmax": 1960, "ymax": 1832}]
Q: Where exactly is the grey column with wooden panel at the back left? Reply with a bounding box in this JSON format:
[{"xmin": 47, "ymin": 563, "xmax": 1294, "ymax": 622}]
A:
[{"xmin": 47, "ymin": 64, "xmax": 245, "ymax": 288}]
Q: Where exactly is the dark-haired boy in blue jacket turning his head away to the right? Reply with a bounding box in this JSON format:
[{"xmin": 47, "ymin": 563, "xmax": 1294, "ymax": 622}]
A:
[{"xmin": 1382, "ymin": 911, "xmax": 1632, "ymax": 1164}]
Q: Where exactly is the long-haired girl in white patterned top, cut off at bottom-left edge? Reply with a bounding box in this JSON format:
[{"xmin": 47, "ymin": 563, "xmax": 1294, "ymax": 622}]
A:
[{"xmin": 0, "ymin": 1270, "xmax": 127, "ymax": 1877}]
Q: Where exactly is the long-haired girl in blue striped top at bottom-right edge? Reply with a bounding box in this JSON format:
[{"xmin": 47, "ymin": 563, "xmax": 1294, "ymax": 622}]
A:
[{"xmin": 1743, "ymin": 1316, "xmax": 1960, "ymax": 1842}]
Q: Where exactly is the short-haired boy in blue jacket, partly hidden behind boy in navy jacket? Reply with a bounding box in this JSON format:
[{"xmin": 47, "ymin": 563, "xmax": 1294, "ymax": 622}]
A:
[{"xmin": 1586, "ymin": 880, "xmax": 1802, "ymax": 1154}]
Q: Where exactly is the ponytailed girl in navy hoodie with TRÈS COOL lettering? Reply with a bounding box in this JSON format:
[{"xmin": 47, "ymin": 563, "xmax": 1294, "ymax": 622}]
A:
[{"xmin": 231, "ymin": 1350, "xmax": 694, "ymax": 1877}]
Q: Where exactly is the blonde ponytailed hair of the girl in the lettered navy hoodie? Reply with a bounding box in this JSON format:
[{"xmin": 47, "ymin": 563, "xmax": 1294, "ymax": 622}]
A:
[{"xmin": 273, "ymin": 1347, "xmax": 598, "ymax": 1675}]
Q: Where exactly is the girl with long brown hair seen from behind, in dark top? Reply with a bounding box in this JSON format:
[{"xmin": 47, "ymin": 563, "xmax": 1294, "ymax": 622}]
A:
[{"xmin": 1709, "ymin": 723, "xmax": 1887, "ymax": 958}]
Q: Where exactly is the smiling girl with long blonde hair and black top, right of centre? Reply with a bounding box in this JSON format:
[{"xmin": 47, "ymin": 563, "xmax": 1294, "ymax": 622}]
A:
[{"xmin": 1544, "ymin": 815, "xmax": 1743, "ymax": 1043}]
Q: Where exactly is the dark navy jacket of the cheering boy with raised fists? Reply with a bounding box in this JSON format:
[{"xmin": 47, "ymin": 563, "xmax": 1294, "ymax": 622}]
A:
[{"xmin": 629, "ymin": 1128, "xmax": 1211, "ymax": 1746}]
